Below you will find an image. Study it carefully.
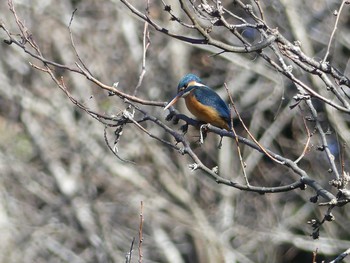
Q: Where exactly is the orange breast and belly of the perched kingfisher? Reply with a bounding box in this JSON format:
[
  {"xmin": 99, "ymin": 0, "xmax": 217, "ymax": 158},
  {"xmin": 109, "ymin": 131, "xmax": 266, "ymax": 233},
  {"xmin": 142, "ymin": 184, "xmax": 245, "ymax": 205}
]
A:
[{"xmin": 185, "ymin": 92, "xmax": 229, "ymax": 130}]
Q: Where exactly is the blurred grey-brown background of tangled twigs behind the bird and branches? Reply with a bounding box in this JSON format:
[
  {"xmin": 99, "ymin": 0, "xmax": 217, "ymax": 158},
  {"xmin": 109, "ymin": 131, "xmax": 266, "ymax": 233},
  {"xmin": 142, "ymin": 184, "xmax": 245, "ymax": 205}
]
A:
[{"xmin": 0, "ymin": 0, "xmax": 350, "ymax": 263}]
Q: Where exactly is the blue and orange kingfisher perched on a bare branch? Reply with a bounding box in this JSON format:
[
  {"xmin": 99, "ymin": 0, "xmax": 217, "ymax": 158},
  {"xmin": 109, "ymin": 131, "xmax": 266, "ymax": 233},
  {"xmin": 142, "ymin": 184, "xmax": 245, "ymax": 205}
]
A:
[{"xmin": 164, "ymin": 74, "xmax": 231, "ymax": 130}]
